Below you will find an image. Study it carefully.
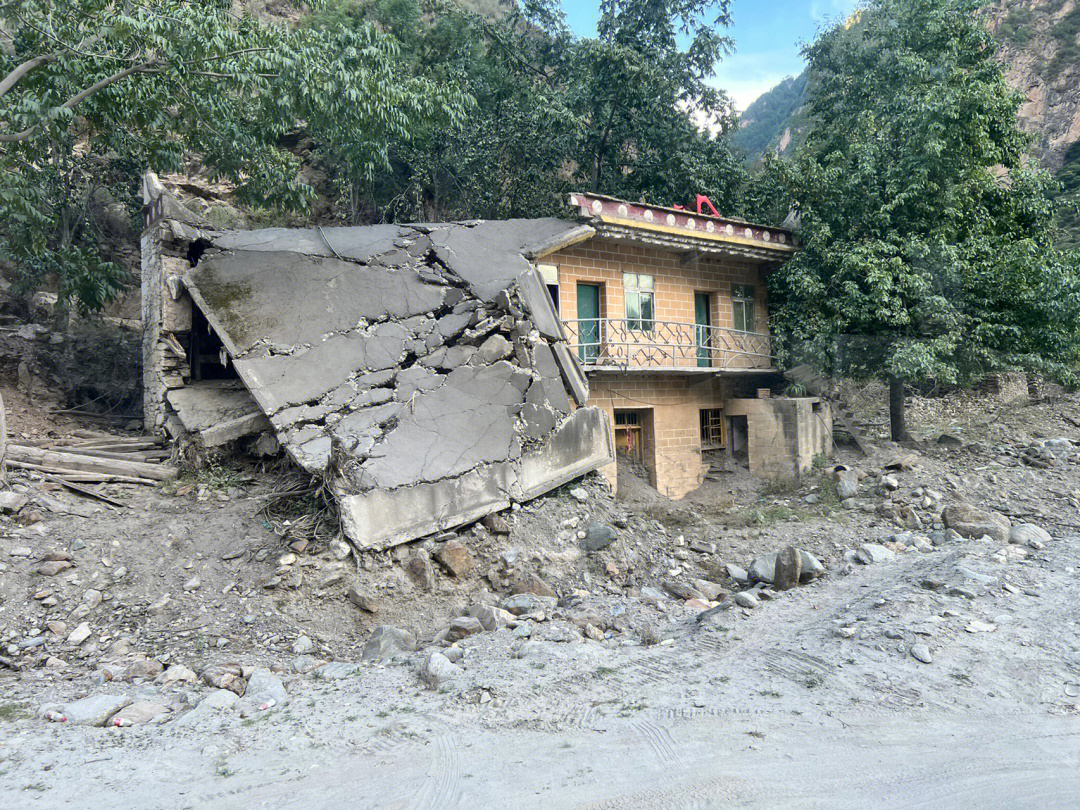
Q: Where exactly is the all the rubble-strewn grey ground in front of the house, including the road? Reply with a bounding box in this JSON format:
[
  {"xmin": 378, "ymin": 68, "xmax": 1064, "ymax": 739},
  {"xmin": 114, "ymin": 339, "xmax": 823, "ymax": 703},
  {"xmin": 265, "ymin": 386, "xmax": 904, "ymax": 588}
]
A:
[{"xmin": 0, "ymin": 382, "xmax": 1080, "ymax": 808}]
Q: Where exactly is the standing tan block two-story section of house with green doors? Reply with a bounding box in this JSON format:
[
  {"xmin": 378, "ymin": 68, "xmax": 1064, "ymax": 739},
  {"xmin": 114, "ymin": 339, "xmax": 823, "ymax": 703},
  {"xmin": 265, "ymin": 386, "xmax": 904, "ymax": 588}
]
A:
[{"xmin": 535, "ymin": 193, "xmax": 833, "ymax": 498}]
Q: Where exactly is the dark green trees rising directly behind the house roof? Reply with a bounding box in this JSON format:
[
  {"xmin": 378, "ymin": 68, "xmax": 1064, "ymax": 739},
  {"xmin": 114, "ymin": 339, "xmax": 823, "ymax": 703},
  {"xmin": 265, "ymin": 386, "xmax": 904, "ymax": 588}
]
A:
[{"xmin": 309, "ymin": 0, "xmax": 745, "ymax": 221}]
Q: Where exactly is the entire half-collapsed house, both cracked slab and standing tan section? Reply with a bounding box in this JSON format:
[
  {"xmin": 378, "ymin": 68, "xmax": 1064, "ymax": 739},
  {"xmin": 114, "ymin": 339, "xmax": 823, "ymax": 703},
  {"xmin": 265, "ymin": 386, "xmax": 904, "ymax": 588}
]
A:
[{"xmin": 141, "ymin": 173, "xmax": 832, "ymax": 549}]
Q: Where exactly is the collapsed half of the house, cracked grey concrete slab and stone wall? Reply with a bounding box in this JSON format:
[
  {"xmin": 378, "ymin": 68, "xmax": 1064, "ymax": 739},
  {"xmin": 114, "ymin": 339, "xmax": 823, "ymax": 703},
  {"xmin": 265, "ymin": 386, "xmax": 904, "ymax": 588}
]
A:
[{"xmin": 143, "ymin": 173, "xmax": 615, "ymax": 549}]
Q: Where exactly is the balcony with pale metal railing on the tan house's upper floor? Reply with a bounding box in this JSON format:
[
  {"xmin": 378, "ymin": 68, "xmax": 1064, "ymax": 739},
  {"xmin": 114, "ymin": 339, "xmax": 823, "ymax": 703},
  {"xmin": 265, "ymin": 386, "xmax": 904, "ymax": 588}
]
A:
[{"xmin": 563, "ymin": 318, "xmax": 772, "ymax": 372}]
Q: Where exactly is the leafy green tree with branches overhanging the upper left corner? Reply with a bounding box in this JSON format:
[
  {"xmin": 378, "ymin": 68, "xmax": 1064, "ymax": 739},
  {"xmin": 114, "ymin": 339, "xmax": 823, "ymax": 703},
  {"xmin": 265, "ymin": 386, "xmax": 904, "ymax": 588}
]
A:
[{"xmin": 0, "ymin": 0, "xmax": 467, "ymax": 309}]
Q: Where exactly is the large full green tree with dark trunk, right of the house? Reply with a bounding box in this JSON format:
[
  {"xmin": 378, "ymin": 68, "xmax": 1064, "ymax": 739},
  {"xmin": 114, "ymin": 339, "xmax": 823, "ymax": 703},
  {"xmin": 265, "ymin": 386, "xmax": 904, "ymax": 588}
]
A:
[{"xmin": 773, "ymin": 0, "xmax": 1080, "ymax": 441}]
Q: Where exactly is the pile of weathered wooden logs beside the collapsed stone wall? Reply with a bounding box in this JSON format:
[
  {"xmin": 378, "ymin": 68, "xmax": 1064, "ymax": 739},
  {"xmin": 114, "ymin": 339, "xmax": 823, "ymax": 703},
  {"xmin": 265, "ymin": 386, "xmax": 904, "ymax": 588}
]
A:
[{"xmin": 6, "ymin": 430, "xmax": 179, "ymax": 502}]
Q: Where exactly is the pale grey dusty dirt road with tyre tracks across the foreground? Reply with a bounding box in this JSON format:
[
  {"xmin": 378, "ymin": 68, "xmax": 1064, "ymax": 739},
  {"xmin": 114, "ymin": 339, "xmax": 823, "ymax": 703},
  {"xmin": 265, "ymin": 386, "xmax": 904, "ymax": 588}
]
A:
[{"xmin": 8, "ymin": 529, "xmax": 1080, "ymax": 810}]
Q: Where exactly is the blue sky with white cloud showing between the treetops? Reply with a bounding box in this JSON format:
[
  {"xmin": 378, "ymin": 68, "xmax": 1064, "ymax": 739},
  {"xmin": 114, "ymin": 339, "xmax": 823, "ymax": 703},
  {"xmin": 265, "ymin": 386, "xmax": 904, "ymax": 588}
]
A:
[{"xmin": 563, "ymin": 0, "xmax": 856, "ymax": 110}]
